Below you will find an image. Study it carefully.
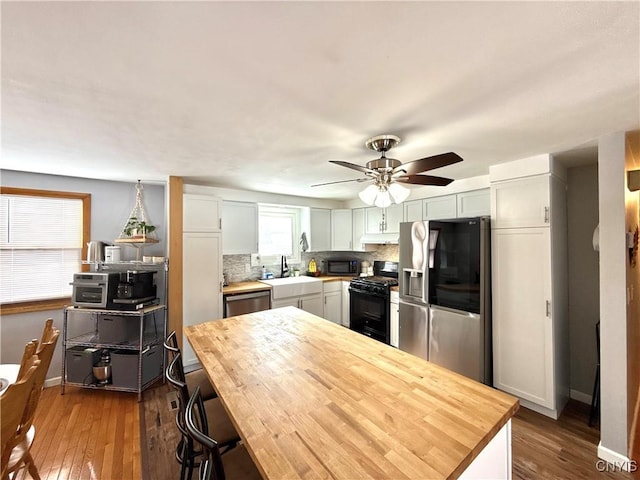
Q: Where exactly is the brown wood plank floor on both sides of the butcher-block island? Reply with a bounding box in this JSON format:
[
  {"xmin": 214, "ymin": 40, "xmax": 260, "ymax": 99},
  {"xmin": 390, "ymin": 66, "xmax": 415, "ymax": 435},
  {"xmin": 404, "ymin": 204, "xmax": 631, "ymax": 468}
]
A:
[{"xmin": 25, "ymin": 385, "xmax": 640, "ymax": 480}]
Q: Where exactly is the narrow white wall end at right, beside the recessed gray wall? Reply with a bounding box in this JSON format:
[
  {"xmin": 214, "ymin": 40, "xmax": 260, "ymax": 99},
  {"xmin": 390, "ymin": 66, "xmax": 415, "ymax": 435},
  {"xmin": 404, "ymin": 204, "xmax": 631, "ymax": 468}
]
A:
[{"xmin": 598, "ymin": 133, "xmax": 628, "ymax": 461}]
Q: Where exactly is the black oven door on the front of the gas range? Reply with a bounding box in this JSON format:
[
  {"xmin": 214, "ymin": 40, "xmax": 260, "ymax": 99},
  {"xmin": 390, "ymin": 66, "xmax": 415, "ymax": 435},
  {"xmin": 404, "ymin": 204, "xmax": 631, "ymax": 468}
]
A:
[{"xmin": 349, "ymin": 287, "xmax": 390, "ymax": 345}]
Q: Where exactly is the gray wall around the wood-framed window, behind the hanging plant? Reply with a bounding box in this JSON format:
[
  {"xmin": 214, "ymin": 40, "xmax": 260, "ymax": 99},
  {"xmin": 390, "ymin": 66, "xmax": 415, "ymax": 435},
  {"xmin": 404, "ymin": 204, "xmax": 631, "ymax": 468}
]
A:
[{"xmin": 0, "ymin": 170, "xmax": 167, "ymax": 378}]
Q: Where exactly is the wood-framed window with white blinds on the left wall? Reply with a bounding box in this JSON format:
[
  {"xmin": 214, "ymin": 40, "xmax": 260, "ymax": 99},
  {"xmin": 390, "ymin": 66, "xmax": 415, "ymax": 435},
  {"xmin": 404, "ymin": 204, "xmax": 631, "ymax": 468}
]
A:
[{"xmin": 0, "ymin": 187, "xmax": 91, "ymax": 314}]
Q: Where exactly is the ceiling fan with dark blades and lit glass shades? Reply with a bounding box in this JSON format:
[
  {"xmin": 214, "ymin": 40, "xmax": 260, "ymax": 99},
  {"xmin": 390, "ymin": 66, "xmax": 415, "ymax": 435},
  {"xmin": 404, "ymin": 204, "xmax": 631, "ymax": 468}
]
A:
[{"xmin": 312, "ymin": 135, "xmax": 462, "ymax": 208}]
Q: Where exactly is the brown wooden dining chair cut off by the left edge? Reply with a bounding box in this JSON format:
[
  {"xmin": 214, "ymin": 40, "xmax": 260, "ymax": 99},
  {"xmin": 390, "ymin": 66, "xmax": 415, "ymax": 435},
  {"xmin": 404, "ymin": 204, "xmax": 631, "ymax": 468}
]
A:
[{"xmin": 0, "ymin": 354, "xmax": 40, "ymax": 480}]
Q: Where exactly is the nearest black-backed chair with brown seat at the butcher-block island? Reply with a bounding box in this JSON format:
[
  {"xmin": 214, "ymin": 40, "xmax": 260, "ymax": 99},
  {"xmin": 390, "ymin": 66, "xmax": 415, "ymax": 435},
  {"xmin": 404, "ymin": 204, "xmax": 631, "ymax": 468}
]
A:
[{"xmin": 185, "ymin": 387, "xmax": 262, "ymax": 480}]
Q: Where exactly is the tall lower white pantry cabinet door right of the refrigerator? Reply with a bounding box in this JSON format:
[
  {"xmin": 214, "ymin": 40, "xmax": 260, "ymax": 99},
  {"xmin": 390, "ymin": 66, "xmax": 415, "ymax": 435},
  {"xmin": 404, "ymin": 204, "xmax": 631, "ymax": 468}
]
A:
[{"xmin": 492, "ymin": 228, "xmax": 555, "ymax": 409}]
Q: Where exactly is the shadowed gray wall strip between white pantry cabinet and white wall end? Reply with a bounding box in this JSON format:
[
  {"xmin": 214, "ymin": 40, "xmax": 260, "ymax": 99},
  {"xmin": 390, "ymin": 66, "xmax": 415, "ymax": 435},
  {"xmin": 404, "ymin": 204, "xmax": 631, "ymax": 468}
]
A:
[{"xmin": 567, "ymin": 164, "xmax": 600, "ymax": 400}]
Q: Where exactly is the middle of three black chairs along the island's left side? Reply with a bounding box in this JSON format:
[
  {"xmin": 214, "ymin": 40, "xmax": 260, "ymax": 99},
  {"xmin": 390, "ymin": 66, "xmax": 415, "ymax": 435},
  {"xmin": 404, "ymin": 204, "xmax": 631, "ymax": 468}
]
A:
[{"xmin": 165, "ymin": 353, "xmax": 240, "ymax": 479}]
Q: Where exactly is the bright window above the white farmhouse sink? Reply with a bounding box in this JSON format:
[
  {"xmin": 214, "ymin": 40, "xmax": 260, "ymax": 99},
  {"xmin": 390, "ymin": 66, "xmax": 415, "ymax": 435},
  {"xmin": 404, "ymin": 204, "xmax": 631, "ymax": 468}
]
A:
[{"xmin": 258, "ymin": 204, "xmax": 302, "ymax": 265}]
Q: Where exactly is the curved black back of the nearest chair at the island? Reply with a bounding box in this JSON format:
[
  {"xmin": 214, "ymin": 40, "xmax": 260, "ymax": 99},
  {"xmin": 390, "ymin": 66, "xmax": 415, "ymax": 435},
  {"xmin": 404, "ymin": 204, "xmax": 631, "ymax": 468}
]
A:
[{"xmin": 185, "ymin": 387, "xmax": 225, "ymax": 480}]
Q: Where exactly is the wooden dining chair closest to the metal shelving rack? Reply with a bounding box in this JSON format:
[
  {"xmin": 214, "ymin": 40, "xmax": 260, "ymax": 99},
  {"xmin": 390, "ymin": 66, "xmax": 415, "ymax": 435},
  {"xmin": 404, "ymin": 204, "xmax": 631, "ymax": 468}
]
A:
[{"xmin": 7, "ymin": 319, "xmax": 60, "ymax": 480}]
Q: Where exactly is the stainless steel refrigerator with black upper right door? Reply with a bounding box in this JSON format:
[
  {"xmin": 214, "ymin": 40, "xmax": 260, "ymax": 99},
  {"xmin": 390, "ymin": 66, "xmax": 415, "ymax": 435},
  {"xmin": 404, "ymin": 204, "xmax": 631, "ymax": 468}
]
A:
[{"xmin": 398, "ymin": 217, "xmax": 492, "ymax": 385}]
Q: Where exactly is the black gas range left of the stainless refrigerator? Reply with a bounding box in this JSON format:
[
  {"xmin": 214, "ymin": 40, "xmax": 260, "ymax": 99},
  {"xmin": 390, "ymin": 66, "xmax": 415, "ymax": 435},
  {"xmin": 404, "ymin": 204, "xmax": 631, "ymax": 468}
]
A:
[{"xmin": 349, "ymin": 261, "xmax": 398, "ymax": 344}]
